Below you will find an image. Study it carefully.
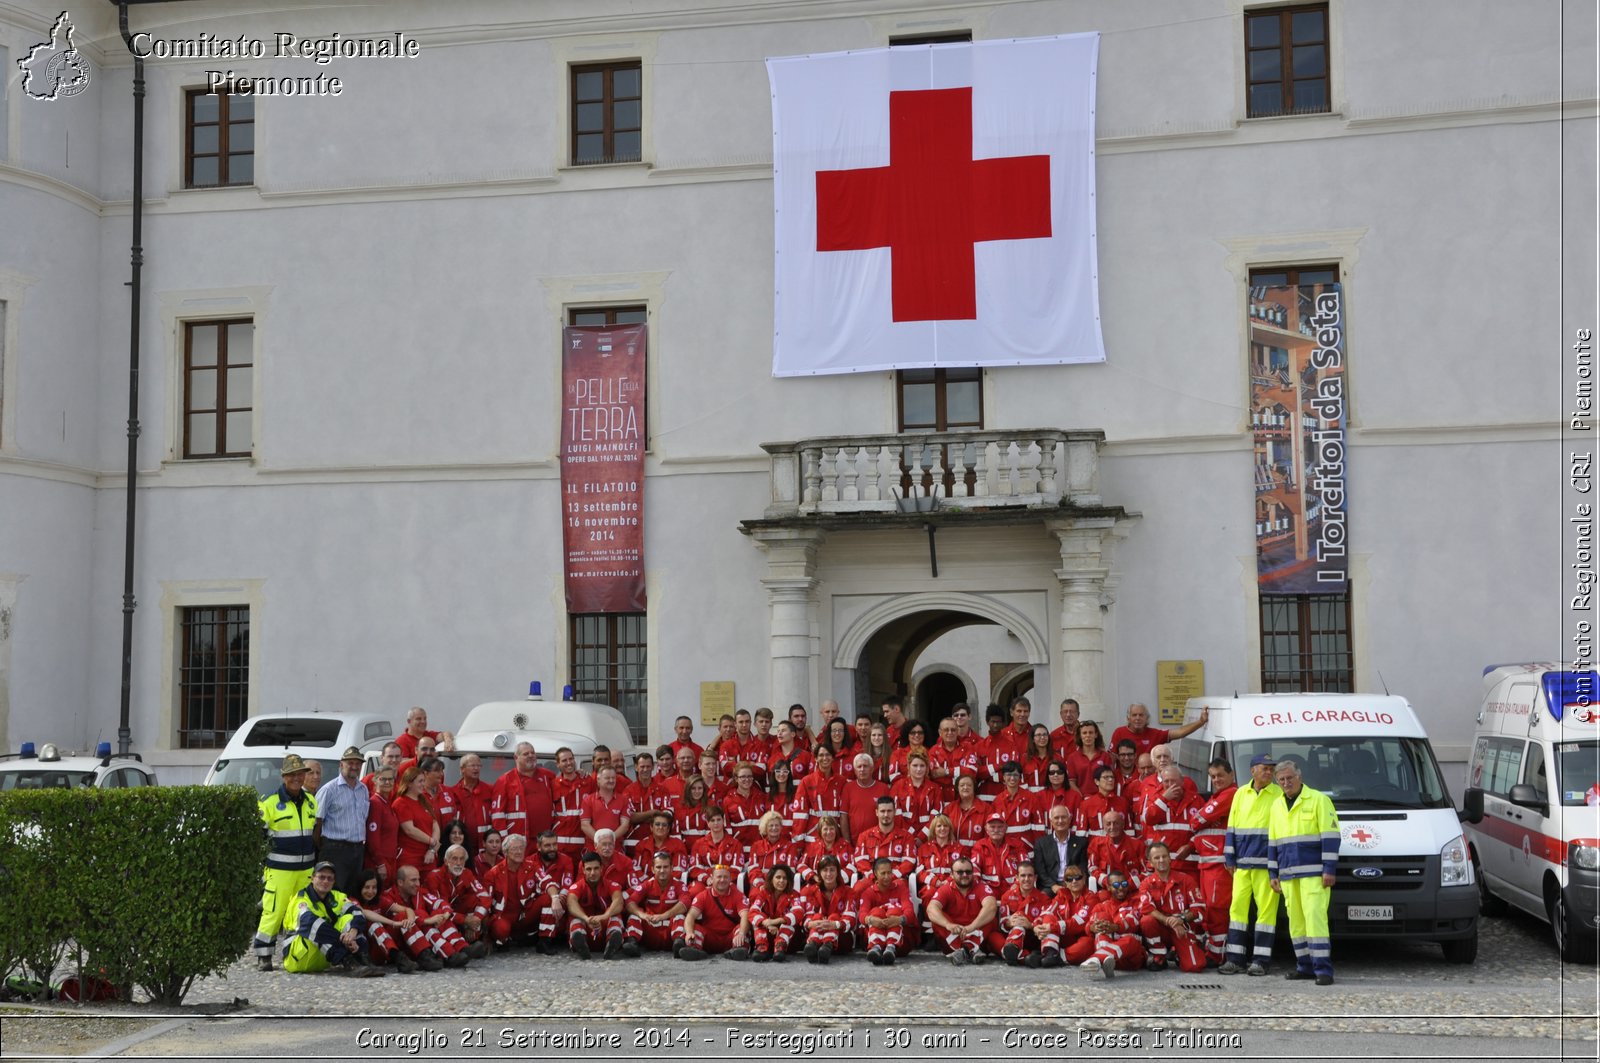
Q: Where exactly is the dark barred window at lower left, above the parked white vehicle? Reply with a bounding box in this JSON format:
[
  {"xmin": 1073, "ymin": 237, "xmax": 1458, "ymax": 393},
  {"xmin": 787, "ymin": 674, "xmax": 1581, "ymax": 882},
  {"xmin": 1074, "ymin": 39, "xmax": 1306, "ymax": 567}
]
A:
[{"xmin": 178, "ymin": 605, "xmax": 250, "ymax": 749}]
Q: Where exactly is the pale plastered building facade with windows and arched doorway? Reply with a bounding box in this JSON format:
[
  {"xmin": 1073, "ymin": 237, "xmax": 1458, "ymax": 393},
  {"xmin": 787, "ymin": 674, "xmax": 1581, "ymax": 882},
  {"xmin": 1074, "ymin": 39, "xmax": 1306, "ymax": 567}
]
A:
[{"xmin": 0, "ymin": 0, "xmax": 1595, "ymax": 781}]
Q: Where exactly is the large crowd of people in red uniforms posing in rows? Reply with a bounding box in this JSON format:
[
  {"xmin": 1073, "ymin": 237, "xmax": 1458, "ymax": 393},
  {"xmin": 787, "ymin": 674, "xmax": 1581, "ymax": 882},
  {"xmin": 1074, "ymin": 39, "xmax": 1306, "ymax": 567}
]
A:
[{"xmin": 321, "ymin": 698, "xmax": 1234, "ymax": 977}]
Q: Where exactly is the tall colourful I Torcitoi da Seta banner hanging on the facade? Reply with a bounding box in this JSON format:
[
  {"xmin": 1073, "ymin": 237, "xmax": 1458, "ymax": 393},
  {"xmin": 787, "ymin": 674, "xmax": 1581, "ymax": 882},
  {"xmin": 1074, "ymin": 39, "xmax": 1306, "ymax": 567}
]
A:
[{"xmin": 1248, "ymin": 283, "xmax": 1349, "ymax": 594}]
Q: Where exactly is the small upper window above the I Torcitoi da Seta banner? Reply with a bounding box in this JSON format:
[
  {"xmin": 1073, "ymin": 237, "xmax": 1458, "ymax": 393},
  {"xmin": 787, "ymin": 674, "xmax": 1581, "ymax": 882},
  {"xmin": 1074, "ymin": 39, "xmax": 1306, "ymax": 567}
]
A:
[{"xmin": 1245, "ymin": 3, "xmax": 1333, "ymax": 118}]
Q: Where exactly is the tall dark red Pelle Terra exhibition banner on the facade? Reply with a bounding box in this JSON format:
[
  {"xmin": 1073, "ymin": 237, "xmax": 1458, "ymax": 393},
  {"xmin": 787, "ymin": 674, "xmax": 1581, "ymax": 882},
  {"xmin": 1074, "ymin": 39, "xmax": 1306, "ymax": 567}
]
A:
[{"xmin": 562, "ymin": 325, "xmax": 645, "ymax": 613}]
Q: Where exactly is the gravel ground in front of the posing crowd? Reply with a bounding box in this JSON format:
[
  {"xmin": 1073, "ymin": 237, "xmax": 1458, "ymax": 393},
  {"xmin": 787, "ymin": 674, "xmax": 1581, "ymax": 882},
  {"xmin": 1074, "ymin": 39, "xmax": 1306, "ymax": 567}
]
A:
[{"xmin": 0, "ymin": 916, "xmax": 1597, "ymax": 1055}]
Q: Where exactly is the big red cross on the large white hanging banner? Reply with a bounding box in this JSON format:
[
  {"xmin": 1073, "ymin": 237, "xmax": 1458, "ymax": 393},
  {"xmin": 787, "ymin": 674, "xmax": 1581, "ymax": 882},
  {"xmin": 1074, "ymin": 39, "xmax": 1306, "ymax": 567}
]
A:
[{"xmin": 816, "ymin": 88, "xmax": 1050, "ymax": 322}]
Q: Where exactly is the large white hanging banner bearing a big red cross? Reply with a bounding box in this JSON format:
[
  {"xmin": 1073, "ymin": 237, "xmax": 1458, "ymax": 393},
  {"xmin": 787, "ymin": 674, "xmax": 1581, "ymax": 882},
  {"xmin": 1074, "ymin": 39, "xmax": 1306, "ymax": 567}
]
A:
[{"xmin": 766, "ymin": 34, "xmax": 1106, "ymax": 376}]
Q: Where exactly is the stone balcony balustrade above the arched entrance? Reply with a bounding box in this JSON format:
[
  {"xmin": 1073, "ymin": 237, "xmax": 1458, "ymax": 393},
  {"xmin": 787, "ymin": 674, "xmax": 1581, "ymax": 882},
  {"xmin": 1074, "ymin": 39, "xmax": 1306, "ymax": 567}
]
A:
[{"xmin": 762, "ymin": 429, "xmax": 1106, "ymax": 520}]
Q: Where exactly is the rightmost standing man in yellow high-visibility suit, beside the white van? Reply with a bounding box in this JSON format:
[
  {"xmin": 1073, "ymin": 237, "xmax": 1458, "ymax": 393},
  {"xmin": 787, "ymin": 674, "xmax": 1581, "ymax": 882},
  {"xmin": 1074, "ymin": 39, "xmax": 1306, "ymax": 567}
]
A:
[{"xmin": 1267, "ymin": 760, "xmax": 1339, "ymax": 986}]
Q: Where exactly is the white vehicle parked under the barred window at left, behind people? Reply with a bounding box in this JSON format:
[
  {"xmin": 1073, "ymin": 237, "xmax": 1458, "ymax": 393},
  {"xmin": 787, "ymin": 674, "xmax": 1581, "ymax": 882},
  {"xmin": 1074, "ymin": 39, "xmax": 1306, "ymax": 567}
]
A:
[{"xmin": 205, "ymin": 712, "xmax": 395, "ymax": 797}]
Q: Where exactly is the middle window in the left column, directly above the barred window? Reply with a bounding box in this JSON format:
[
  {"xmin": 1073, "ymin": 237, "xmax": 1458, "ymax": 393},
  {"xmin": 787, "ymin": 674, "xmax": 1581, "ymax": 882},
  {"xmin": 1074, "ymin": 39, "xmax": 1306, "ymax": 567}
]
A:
[{"xmin": 184, "ymin": 319, "xmax": 256, "ymax": 458}]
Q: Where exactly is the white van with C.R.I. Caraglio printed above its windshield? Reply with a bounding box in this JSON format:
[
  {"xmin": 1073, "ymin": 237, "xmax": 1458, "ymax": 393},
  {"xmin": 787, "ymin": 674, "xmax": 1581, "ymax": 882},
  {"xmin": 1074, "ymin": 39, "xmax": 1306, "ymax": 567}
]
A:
[{"xmin": 1176, "ymin": 693, "xmax": 1478, "ymax": 964}]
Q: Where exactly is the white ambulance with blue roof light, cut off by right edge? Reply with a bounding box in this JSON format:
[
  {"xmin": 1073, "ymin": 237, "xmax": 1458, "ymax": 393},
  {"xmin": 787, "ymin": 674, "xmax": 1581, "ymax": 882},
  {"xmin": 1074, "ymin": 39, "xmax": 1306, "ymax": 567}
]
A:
[{"xmin": 1464, "ymin": 663, "xmax": 1600, "ymax": 959}]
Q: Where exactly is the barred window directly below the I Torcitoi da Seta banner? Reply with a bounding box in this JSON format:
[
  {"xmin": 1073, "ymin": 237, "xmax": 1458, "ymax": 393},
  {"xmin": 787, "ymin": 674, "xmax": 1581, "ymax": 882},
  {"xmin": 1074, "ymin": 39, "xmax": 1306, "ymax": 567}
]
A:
[{"xmin": 1261, "ymin": 594, "xmax": 1355, "ymax": 693}]
